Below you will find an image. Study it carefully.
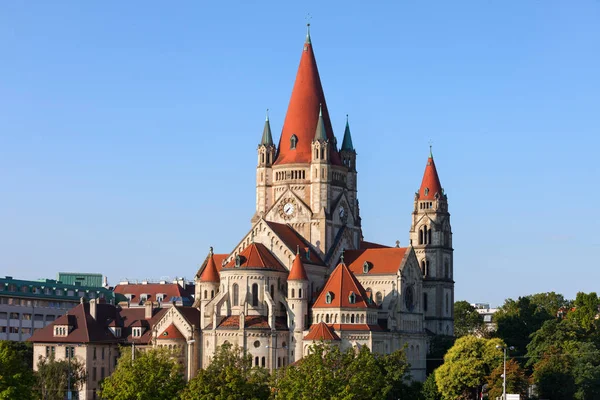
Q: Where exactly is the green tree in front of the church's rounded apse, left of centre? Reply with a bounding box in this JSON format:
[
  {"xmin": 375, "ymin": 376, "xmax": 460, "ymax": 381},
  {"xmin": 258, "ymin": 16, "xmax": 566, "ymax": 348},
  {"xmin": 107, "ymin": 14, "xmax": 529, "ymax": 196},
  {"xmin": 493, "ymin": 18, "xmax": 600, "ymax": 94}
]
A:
[{"xmin": 180, "ymin": 344, "xmax": 270, "ymax": 400}]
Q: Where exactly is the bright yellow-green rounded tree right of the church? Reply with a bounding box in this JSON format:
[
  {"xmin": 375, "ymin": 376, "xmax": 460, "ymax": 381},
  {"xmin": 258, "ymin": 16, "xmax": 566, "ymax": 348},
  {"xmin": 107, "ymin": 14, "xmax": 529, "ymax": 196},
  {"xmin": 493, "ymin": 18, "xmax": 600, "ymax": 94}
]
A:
[{"xmin": 435, "ymin": 336, "xmax": 504, "ymax": 400}]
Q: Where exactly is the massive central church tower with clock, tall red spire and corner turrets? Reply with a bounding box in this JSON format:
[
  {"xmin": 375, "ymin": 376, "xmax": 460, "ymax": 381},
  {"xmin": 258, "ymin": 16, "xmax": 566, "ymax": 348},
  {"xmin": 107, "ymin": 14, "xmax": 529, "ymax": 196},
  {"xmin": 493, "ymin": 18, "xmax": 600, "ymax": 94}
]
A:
[{"xmin": 252, "ymin": 26, "xmax": 362, "ymax": 266}]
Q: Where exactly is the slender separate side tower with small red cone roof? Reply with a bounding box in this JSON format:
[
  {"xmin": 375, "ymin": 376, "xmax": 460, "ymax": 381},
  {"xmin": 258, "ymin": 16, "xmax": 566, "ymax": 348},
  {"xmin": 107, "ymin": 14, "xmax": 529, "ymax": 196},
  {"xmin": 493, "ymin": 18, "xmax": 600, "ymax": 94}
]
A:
[{"xmin": 410, "ymin": 149, "xmax": 454, "ymax": 335}]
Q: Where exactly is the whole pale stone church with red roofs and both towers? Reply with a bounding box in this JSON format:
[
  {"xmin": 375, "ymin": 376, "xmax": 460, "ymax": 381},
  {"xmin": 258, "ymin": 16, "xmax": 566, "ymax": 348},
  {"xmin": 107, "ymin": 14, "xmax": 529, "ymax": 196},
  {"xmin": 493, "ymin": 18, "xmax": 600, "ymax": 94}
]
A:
[{"xmin": 195, "ymin": 25, "xmax": 454, "ymax": 380}]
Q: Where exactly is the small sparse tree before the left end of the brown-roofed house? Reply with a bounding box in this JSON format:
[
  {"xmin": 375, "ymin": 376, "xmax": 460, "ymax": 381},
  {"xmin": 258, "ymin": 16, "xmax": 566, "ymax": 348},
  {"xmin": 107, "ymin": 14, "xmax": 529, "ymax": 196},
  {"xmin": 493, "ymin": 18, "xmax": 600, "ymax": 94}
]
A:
[{"xmin": 36, "ymin": 356, "xmax": 87, "ymax": 400}]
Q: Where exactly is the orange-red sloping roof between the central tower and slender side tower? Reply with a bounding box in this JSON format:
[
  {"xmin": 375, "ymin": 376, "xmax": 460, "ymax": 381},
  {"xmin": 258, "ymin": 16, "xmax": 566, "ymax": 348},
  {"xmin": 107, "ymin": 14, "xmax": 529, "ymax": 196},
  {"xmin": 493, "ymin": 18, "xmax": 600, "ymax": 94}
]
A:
[{"xmin": 344, "ymin": 247, "xmax": 408, "ymax": 275}]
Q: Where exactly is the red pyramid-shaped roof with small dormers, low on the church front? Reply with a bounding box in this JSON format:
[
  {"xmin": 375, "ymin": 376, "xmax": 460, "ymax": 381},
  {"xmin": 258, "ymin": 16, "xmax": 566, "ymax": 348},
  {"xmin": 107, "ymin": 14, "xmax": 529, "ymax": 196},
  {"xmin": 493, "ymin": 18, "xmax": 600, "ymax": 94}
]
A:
[{"xmin": 313, "ymin": 263, "xmax": 377, "ymax": 308}]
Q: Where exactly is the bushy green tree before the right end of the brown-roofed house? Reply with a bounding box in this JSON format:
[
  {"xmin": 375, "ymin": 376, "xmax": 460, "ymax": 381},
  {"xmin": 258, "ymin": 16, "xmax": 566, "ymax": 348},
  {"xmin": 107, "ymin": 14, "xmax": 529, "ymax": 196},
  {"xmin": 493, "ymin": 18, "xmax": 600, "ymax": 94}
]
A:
[{"xmin": 100, "ymin": 347, "xmax": 185, "ymax": 400}]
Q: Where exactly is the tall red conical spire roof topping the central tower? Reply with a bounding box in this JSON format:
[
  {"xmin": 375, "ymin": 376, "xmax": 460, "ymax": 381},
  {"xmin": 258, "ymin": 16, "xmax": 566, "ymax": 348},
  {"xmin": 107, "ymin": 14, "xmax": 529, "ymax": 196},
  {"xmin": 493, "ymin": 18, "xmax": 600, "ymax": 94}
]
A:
[{"xmin": 275, "ymin": 28, "xmax": 342, "ymax": 165}]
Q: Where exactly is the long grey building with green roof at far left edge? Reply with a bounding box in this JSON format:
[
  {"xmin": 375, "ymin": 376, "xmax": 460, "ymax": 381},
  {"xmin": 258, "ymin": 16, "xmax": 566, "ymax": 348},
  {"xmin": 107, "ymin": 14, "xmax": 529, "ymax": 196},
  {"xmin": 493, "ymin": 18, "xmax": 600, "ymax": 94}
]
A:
[{"xmin": 0, "ymin": 276, "xmax": 114, "ymax": 342}]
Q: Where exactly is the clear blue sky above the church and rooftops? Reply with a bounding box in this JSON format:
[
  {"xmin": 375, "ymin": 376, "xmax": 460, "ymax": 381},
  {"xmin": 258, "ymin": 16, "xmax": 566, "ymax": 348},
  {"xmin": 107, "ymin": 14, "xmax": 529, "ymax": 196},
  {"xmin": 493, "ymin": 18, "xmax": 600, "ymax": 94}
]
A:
[{"xmin": 0, "ymin": 0, "xmax": 600, "ymax": 305}]
